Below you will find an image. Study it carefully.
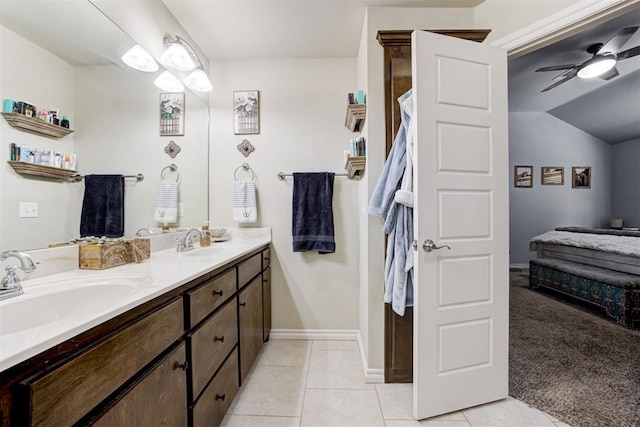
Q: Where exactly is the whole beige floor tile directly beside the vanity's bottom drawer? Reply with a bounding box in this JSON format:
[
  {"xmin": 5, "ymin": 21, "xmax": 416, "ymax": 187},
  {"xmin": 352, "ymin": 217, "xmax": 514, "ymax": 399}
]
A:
[{"xmin": 228, "ymin": 366, "xmax": 306, "ymax": 417}]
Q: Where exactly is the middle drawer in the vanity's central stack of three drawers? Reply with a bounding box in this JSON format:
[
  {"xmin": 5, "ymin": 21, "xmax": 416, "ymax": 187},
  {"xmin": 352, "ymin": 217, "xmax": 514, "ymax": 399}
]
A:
[{"xmin": 189, "ymin": 298, "xmax": 238, "ymax": 399}]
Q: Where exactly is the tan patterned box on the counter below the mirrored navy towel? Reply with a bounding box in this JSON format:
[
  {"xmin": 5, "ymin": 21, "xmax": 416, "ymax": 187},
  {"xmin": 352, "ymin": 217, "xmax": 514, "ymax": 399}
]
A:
[{"xmin": 79, "ymin": 238, "xmax": 151, "ymax": 270}]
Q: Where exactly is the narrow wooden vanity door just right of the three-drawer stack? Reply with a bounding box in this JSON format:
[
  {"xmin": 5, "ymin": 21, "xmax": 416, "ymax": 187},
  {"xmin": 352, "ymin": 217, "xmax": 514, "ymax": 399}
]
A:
[{"xmin": 238, "ymin": 275, "xmax": 263, "ymax": 385}]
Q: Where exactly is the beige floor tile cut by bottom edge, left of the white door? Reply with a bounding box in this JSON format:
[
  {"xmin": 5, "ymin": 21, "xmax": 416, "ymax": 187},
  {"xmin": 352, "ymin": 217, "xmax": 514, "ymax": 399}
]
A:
[{"xmin": 300, "ymin": 389, "xmax": 384, "ymax": 427}]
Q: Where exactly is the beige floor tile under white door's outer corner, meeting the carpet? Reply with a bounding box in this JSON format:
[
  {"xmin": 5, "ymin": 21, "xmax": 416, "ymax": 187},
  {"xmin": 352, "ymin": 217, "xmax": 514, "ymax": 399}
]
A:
[{"xmin": 462, "ymin": 397, "xmax": 556, "ymax": 427}]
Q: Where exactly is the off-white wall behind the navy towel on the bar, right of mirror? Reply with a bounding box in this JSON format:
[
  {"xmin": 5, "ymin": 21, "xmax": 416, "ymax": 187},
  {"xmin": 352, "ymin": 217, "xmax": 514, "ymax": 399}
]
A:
[{"xmin": 209, "ymin": 58, "xmax": 359, "ymax": 330}]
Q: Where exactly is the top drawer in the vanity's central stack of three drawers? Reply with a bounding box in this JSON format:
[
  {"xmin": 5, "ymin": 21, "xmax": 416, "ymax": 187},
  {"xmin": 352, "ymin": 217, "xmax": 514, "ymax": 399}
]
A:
[{"xmin": 187, "ymin": 268, "xmax": 236, "ymax": 328}]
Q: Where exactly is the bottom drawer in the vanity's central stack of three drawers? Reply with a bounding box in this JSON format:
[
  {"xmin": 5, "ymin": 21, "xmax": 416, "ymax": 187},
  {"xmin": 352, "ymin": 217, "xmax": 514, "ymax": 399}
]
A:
[{"xmin": 193, "ymin": 348, "xmax": 238, "ymax": 427}]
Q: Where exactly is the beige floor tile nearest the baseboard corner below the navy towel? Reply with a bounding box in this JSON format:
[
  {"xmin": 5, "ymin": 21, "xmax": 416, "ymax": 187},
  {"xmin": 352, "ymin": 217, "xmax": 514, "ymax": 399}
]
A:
[{"xmin": 307, "ymin": 350, "xmax": 375, "ymax": 390}]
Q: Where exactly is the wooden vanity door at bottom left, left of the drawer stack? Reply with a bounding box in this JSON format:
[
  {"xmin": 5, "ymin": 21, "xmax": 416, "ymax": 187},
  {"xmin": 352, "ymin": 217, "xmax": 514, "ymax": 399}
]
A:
[{"xmin": 94, "ymin": 343, "xmax": 187, "ymax": 427}]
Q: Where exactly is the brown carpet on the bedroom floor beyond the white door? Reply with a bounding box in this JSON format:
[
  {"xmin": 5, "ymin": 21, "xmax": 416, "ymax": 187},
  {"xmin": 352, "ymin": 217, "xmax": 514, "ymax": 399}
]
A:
[{"xmin": 509, "ymin": 269, "xmax": 640, "ymax": 427}]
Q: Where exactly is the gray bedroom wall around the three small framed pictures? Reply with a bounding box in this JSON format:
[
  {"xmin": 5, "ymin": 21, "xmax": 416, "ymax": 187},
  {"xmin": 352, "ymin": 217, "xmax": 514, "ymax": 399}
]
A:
[{"xmin": 509, "ymin": 112, "xmax": 608, "ymax": 264}]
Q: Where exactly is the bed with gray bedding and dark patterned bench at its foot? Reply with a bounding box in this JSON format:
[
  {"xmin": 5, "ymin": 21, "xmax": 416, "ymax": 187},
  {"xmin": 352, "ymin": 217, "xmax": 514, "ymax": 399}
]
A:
[{"xmin": 529, "ymin": 227, "xmax": 640, "ymax": 328}]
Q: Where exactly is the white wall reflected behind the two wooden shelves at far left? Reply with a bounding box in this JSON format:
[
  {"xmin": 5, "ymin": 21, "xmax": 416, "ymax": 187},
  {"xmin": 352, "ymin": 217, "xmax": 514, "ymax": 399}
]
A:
[{"xmin": 0, "ymin": 27, "xmax": 75, "ymax": 250}]
